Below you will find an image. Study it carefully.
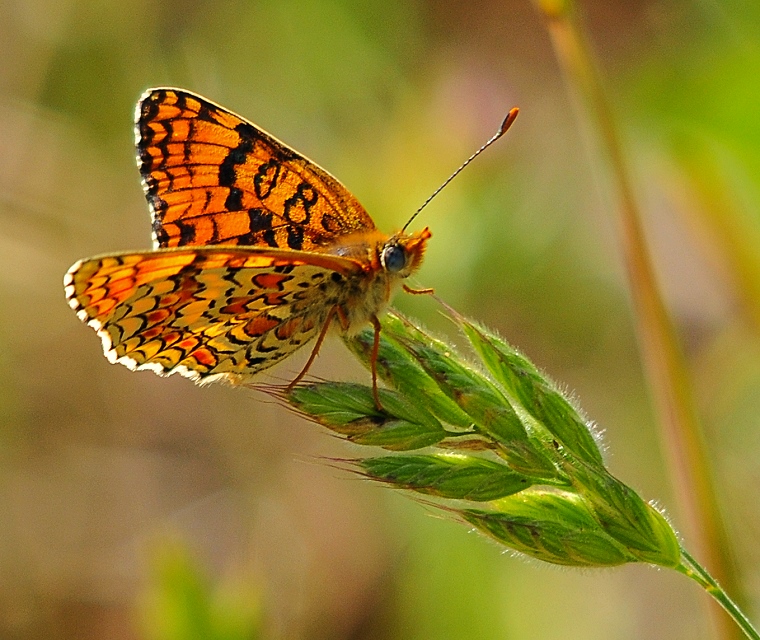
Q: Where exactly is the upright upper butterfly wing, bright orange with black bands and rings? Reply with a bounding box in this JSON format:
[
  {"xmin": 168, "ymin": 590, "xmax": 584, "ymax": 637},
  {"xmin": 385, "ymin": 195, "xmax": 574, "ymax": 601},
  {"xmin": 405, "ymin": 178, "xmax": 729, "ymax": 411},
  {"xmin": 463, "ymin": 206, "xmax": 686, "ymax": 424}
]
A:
[{"xmin": 136, "ymin": 89, "xmax": 375, "ymax": 251}]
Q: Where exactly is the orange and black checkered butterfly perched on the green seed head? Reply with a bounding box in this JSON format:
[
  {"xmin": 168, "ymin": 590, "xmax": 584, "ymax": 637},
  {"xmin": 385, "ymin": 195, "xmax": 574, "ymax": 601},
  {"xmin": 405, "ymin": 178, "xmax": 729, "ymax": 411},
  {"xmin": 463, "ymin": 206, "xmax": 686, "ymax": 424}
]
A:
[{"xmin": 64, "ymin": 89, "xmax": 430, "ymax": 383}]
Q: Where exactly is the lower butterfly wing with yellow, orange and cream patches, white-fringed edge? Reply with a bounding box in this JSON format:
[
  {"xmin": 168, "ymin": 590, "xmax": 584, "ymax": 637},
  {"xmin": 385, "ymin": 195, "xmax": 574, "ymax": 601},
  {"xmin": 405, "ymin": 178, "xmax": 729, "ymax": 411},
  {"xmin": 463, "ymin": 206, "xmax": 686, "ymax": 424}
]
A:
[{"xmin": 65, "ymin": 247, "xmax": 360, "ymax": 382}]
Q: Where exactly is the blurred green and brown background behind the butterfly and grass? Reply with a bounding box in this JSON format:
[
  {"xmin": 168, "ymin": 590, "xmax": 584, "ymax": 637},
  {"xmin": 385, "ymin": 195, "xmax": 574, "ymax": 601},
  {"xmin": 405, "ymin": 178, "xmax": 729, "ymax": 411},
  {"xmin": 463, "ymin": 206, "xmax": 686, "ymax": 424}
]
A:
[{"xmin": 0, "ymin": 0, "xmax": 760, "ymax": 640}]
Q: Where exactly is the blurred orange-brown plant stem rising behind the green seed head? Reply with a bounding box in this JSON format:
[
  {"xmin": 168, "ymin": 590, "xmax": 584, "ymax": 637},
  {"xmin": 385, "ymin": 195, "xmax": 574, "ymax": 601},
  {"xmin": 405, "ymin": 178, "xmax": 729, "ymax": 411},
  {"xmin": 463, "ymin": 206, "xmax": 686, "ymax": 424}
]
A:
[{"xmin": 534, "ymin": 0, "xmax": 739, "ymax": 636}]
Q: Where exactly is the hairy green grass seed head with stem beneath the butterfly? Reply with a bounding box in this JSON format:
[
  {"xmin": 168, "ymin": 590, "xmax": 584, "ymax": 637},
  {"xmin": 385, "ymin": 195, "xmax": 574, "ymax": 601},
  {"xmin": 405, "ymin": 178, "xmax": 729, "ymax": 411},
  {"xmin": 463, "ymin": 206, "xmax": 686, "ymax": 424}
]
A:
[{"xmin": 274, "ymin": 308, "xmax": 760, "ymax": 640}]
